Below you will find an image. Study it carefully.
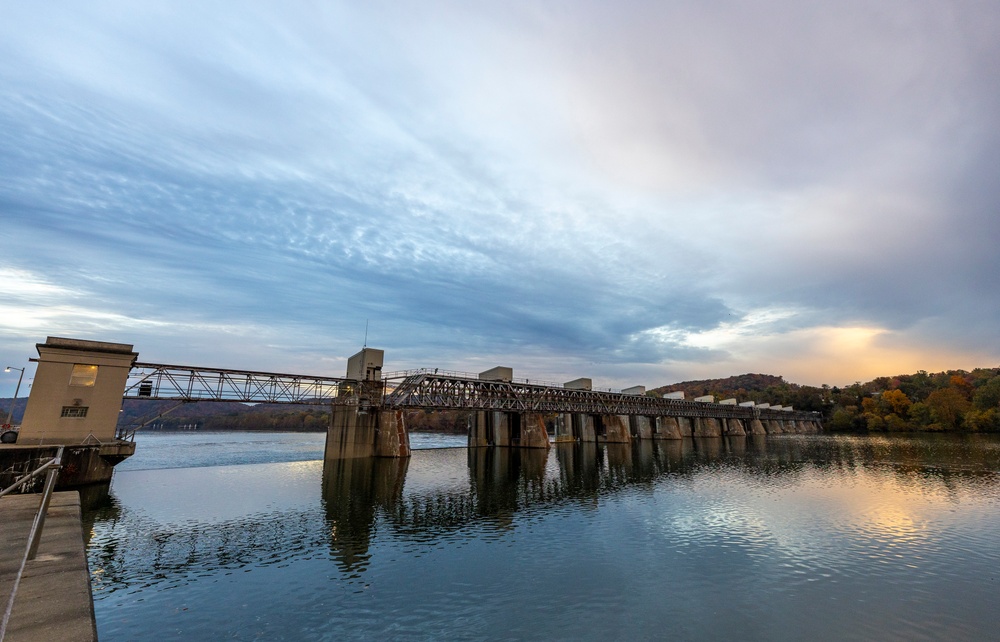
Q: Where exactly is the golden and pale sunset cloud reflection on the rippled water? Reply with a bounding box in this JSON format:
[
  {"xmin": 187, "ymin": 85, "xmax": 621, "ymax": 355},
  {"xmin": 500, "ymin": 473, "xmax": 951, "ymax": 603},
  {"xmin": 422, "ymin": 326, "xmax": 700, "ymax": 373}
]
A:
[{"xmin": 640, "ymin": 458, "xmax": 990, "ymax": 581}]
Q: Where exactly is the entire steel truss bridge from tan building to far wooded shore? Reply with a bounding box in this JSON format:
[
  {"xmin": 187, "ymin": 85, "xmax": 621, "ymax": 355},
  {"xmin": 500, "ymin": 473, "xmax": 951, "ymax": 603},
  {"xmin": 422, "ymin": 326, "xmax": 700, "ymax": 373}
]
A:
[{"xmin": 124, "ymin": 363, "xmax": 818, "ymax": 421}]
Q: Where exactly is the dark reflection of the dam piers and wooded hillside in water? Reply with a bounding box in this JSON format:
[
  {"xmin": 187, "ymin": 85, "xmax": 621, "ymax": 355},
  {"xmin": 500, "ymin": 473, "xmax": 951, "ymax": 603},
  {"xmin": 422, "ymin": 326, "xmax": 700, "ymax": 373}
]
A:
[{"xmin": 314, "ymin": 435, "xmax": 1000, "ymax": 574}]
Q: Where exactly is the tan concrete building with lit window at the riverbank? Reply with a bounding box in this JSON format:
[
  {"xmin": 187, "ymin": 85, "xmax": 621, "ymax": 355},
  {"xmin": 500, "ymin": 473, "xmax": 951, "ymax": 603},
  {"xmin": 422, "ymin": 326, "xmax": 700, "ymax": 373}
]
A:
[{"xmin": 17, "ymin": 337, "xmax": 139, "ymax": 445}]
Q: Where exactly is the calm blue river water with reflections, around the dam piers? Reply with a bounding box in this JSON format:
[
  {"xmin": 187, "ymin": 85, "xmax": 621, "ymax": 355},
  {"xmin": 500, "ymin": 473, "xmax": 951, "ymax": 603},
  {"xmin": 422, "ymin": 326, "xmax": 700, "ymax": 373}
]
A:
[{"xmin": 85, "ymin": 433, "xmax": 1000, "ymax": 642}]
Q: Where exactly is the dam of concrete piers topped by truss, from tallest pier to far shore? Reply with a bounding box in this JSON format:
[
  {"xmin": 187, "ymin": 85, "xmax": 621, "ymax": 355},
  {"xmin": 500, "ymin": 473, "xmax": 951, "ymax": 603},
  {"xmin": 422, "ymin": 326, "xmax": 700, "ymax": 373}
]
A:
[{"xmin": 325, "ymin": 348, "xmax": 822, "ymax": 460}]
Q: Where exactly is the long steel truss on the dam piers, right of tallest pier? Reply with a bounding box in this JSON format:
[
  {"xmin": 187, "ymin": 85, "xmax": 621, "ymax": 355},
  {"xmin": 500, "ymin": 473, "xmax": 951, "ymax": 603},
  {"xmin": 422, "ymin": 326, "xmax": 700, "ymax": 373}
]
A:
[{"xmin": 383, "ymin": 372, "xmax": 817, "ymax": 421}]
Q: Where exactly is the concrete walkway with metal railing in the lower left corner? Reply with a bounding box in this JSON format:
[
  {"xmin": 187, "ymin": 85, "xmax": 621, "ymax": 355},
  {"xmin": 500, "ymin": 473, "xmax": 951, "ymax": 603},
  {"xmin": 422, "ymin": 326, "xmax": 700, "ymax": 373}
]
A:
[{"xmin": 0, "ymin": 491, "xmax": 97, "ymax": 642}]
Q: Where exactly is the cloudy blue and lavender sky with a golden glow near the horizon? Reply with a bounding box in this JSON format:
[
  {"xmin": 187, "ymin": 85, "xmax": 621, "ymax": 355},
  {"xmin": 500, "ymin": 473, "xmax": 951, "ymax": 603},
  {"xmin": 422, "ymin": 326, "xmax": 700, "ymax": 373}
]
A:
[{"xmin": 0, "ymin": 0, "xmax": 1000, "ymax": 397}]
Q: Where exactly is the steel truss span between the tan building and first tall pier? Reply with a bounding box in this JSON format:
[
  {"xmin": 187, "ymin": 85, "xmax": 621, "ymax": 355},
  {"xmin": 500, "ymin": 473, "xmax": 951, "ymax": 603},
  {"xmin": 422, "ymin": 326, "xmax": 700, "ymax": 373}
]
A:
[{"xmin": 124, "ymin": 363, "xmax": 352, "ymax": 404}]
